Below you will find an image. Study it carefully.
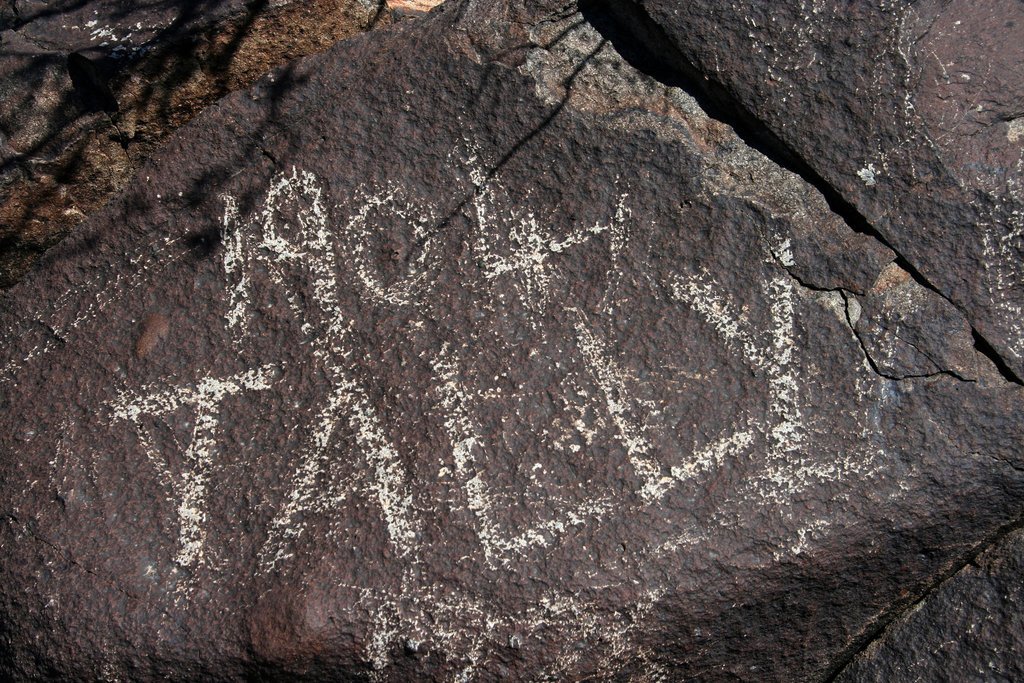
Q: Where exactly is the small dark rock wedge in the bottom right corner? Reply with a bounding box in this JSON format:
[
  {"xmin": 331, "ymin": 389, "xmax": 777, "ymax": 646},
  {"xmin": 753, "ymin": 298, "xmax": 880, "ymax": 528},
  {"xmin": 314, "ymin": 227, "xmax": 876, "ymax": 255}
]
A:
[{"xmin": 836, "ymin": 531, "xmax": 1024, "ymax": 683}]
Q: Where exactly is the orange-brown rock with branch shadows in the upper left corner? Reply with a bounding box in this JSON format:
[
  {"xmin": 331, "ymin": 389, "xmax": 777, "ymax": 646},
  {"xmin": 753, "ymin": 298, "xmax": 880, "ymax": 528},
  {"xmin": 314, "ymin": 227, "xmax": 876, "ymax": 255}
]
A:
[{"xmin": 0, "ymin": 0, "xmax": 382, "ymax": 288}]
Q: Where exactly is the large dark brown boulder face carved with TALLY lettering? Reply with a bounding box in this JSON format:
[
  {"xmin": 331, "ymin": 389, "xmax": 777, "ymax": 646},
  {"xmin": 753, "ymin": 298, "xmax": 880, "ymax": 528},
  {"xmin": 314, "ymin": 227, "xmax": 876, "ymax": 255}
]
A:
[{"xmin": 0, "ymin": 2, "xmax": 1024, "ymax": 681}]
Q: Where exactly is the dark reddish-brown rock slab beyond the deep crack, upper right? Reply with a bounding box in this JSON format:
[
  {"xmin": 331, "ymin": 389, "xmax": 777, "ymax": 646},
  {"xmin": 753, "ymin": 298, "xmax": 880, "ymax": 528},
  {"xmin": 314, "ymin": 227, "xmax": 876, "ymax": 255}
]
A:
[{"xmin": 622, "ymin": 0, "xmax": 1024, "ymax": 378}]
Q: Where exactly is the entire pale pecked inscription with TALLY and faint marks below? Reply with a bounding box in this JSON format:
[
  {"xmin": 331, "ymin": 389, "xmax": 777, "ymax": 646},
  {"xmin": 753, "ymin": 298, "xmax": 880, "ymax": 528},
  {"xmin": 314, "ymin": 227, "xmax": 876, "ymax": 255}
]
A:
[{"xmin": 83, "ymin": 151, "xmax": 831, "ymax": 667}]
